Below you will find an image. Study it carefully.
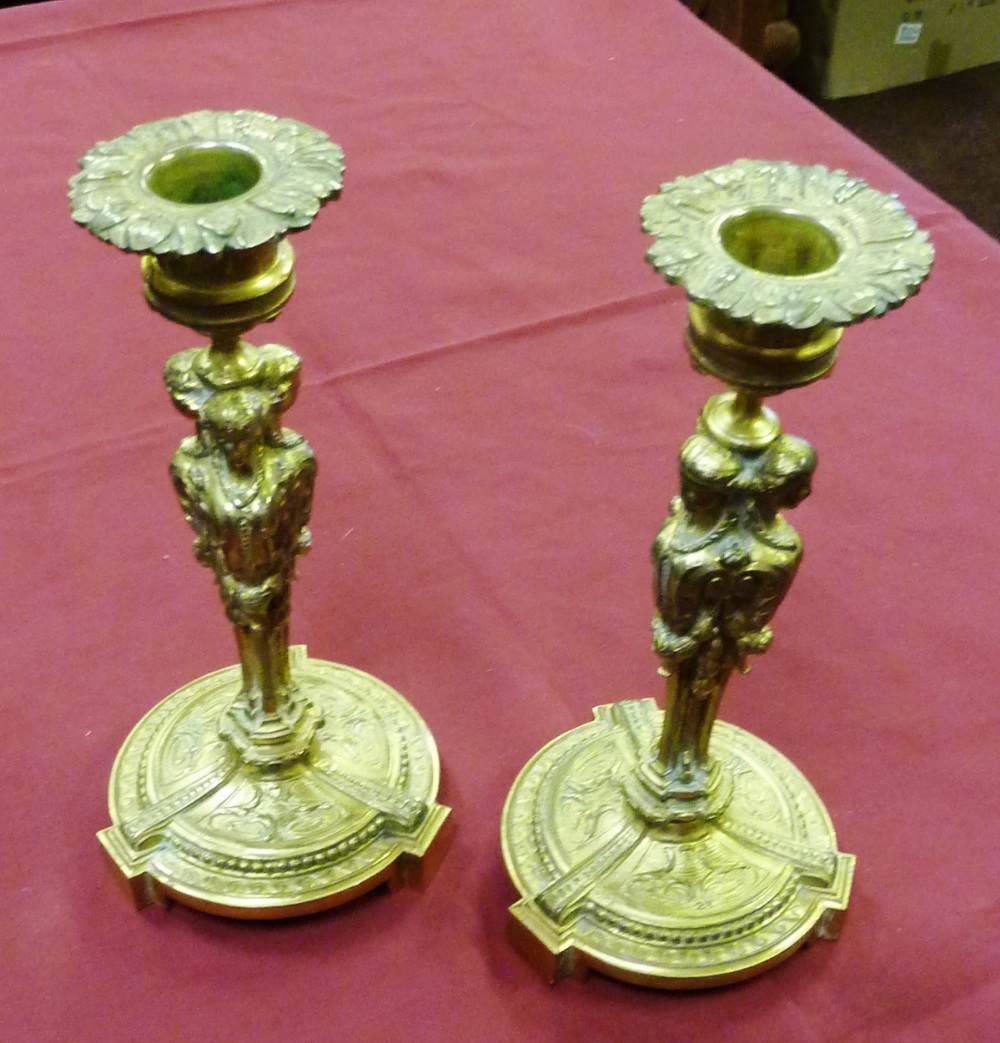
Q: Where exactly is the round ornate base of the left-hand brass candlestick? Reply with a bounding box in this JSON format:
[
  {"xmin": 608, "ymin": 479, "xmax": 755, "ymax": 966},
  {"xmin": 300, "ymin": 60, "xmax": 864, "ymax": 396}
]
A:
[{"xmin": 98, "ymin": 646, "xmax": 448, "ymax": 920}]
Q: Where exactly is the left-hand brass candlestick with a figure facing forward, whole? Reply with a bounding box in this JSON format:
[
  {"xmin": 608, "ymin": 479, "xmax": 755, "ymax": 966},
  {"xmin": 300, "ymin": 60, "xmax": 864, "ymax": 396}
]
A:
[{"xmin": 70, "ymin": 112, "xmax": 447, "ymax": 919}]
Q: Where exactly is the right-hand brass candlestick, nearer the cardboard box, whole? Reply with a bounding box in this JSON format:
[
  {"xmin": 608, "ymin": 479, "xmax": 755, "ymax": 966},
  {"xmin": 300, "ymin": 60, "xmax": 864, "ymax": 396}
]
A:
[{"xmin": 503, "ymin": 160, "xmax": 933, "ymax": 989}]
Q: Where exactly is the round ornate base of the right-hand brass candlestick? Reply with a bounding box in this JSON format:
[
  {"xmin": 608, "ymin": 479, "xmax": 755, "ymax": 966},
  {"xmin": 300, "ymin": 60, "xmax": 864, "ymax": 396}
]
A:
[{"xmin": 502, "ymin": 699, "xmax": 854, "ymax": 989}]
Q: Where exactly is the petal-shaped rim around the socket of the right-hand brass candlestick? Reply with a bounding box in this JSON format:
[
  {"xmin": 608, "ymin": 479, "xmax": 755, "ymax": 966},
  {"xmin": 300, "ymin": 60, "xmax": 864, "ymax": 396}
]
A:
[{"xmin": 641, "ymin": 160, "xmax": 934, "ymax": 329}]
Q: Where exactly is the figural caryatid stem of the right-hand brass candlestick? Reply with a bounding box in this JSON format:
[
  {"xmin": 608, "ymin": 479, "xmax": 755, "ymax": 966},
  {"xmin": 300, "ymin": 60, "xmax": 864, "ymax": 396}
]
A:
[{"xmin": 653, "ymin": 423, "xmax": 815, "ymax": 817}]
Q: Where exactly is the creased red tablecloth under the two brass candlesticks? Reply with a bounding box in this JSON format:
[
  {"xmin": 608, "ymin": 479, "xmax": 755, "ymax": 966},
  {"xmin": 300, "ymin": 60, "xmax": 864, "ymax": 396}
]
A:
[{"xmin": 0, "ymin": 0, "xmax": 1000, "ymax": 1043}]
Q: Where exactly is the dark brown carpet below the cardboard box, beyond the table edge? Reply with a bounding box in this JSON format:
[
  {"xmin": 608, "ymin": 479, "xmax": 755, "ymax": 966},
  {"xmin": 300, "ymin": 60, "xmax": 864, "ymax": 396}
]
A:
[{"xmin": 813, "ymin": 63, "xmax": 1000, "ymax": 239}]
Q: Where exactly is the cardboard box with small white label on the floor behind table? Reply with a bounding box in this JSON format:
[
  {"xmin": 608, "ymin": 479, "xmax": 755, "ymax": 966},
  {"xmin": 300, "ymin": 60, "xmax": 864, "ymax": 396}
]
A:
[{"xmin": 789, "ymin": 0, "xmax": 1000, "ymax": 98}]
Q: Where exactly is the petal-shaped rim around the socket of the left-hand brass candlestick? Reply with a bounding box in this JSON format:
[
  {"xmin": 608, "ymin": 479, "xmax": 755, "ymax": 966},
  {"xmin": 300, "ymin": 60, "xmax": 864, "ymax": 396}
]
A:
[{"xmin": 70, "ymin": 110, "xmax": 344, "ymax": 254}]
